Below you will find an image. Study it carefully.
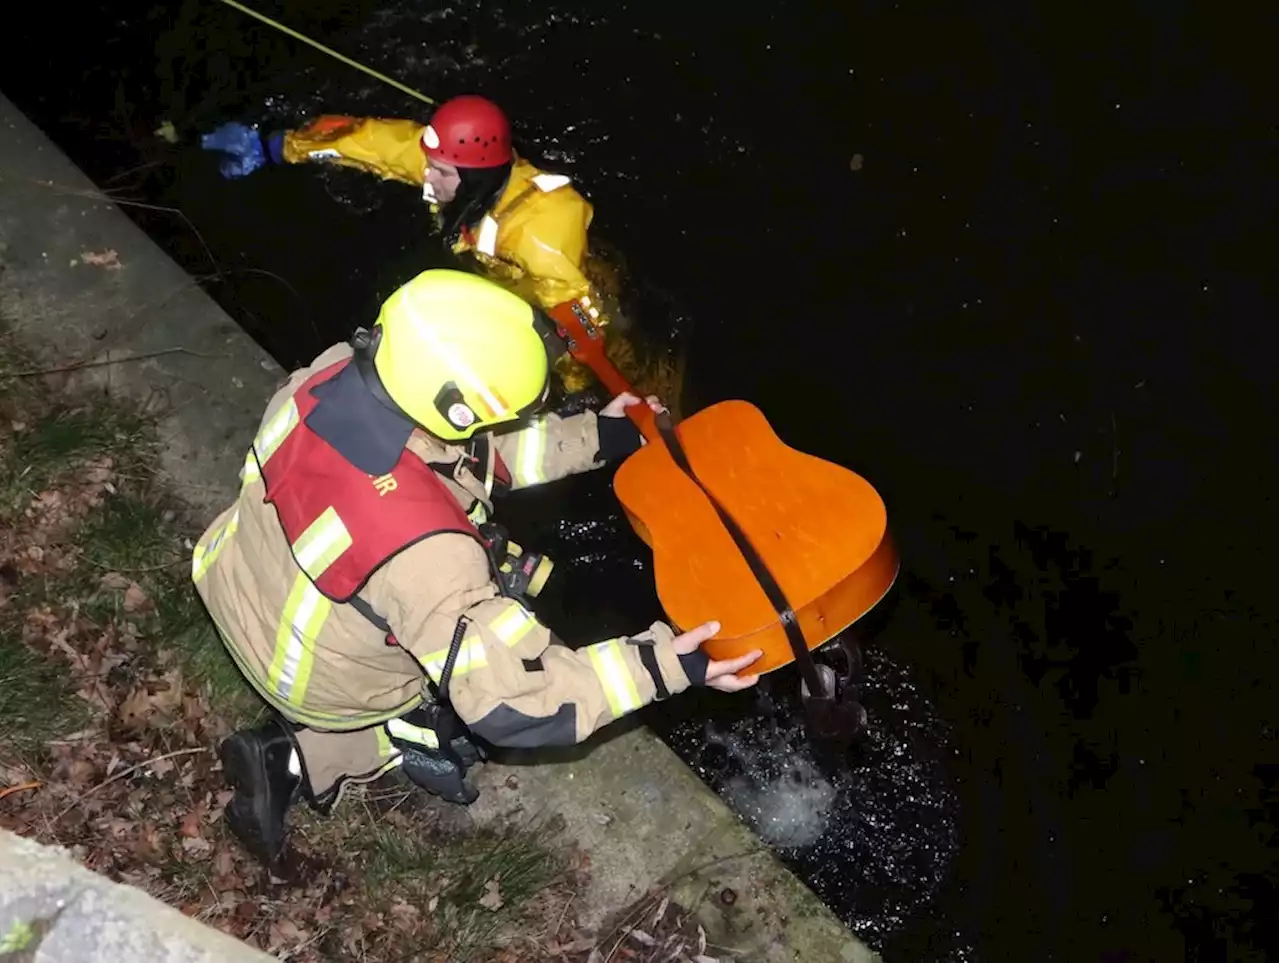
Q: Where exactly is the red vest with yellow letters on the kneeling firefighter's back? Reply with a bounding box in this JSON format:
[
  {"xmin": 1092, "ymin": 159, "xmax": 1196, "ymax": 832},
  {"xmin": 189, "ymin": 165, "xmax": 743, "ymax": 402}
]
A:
[{"xmin": 259, "ymin": 361, "xmax": 483, "ymax": 602}]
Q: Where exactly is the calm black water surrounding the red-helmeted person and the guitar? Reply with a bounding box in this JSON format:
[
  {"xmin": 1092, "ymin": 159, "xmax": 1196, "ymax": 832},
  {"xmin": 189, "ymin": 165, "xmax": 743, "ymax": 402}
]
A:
[{"xmin": 0, "ymin": 0, "xmax": 1280, "ymax": 960}]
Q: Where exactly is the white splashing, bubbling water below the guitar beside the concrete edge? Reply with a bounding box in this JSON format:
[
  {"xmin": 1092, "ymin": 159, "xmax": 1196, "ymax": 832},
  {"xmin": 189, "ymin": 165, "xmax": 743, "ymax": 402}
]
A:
[{"xmin": 668, "ymin": 649, "xmax": 973, "ymax": 960}]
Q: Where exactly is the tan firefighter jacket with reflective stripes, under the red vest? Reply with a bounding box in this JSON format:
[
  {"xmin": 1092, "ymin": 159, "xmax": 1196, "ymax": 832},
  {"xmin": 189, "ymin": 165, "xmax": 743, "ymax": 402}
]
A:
[{"xmin": 192, "ymin": 344, "xmax": 689, "ymax": 747}]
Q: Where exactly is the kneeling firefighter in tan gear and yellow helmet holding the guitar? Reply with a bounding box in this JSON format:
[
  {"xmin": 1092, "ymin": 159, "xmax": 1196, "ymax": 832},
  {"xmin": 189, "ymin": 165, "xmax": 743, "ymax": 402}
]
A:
[{"xmin": 192, "ymin": 270, "xmax": 758, "ymax": 863}]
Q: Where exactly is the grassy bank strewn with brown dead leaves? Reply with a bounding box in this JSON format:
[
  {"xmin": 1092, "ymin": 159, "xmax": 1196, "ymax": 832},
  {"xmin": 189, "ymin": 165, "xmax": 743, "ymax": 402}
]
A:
[{"xmin": 0, "ymin": 334, "xmax": 579, "ymax": 960}]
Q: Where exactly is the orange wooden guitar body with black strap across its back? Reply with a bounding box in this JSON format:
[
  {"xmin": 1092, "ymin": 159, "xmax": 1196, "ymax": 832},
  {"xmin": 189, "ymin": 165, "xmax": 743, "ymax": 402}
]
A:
[{"xmin": 613, "ymin": 401, "xmax": 899, "ymax": 672}]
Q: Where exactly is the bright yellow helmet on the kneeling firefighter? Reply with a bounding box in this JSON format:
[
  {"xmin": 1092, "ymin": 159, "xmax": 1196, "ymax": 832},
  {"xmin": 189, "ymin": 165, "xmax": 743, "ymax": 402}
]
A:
[{"xmin": 374, "ymin": 270, "xmax": 550, "ymax": 442}]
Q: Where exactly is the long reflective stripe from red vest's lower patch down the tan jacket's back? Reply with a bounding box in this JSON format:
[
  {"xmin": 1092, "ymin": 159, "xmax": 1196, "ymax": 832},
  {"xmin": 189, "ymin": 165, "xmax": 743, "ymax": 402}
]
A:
[{"xmin": 266, "ymin": 507, "xmax": 351, "ymax": 706}]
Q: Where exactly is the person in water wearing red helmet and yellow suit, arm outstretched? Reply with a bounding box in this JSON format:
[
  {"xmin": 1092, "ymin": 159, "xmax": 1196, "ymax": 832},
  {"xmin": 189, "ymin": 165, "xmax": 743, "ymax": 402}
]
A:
[{"xmin": 202, "ymin": 95, "xmax": 655, "ymax": 391}]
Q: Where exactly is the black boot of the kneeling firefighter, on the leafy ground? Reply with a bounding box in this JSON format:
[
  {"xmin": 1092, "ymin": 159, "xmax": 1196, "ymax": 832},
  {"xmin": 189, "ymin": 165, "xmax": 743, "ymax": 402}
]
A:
[{"xmin": 218, "ymin": 720, "xmax": 302, "ymax": 867}]
